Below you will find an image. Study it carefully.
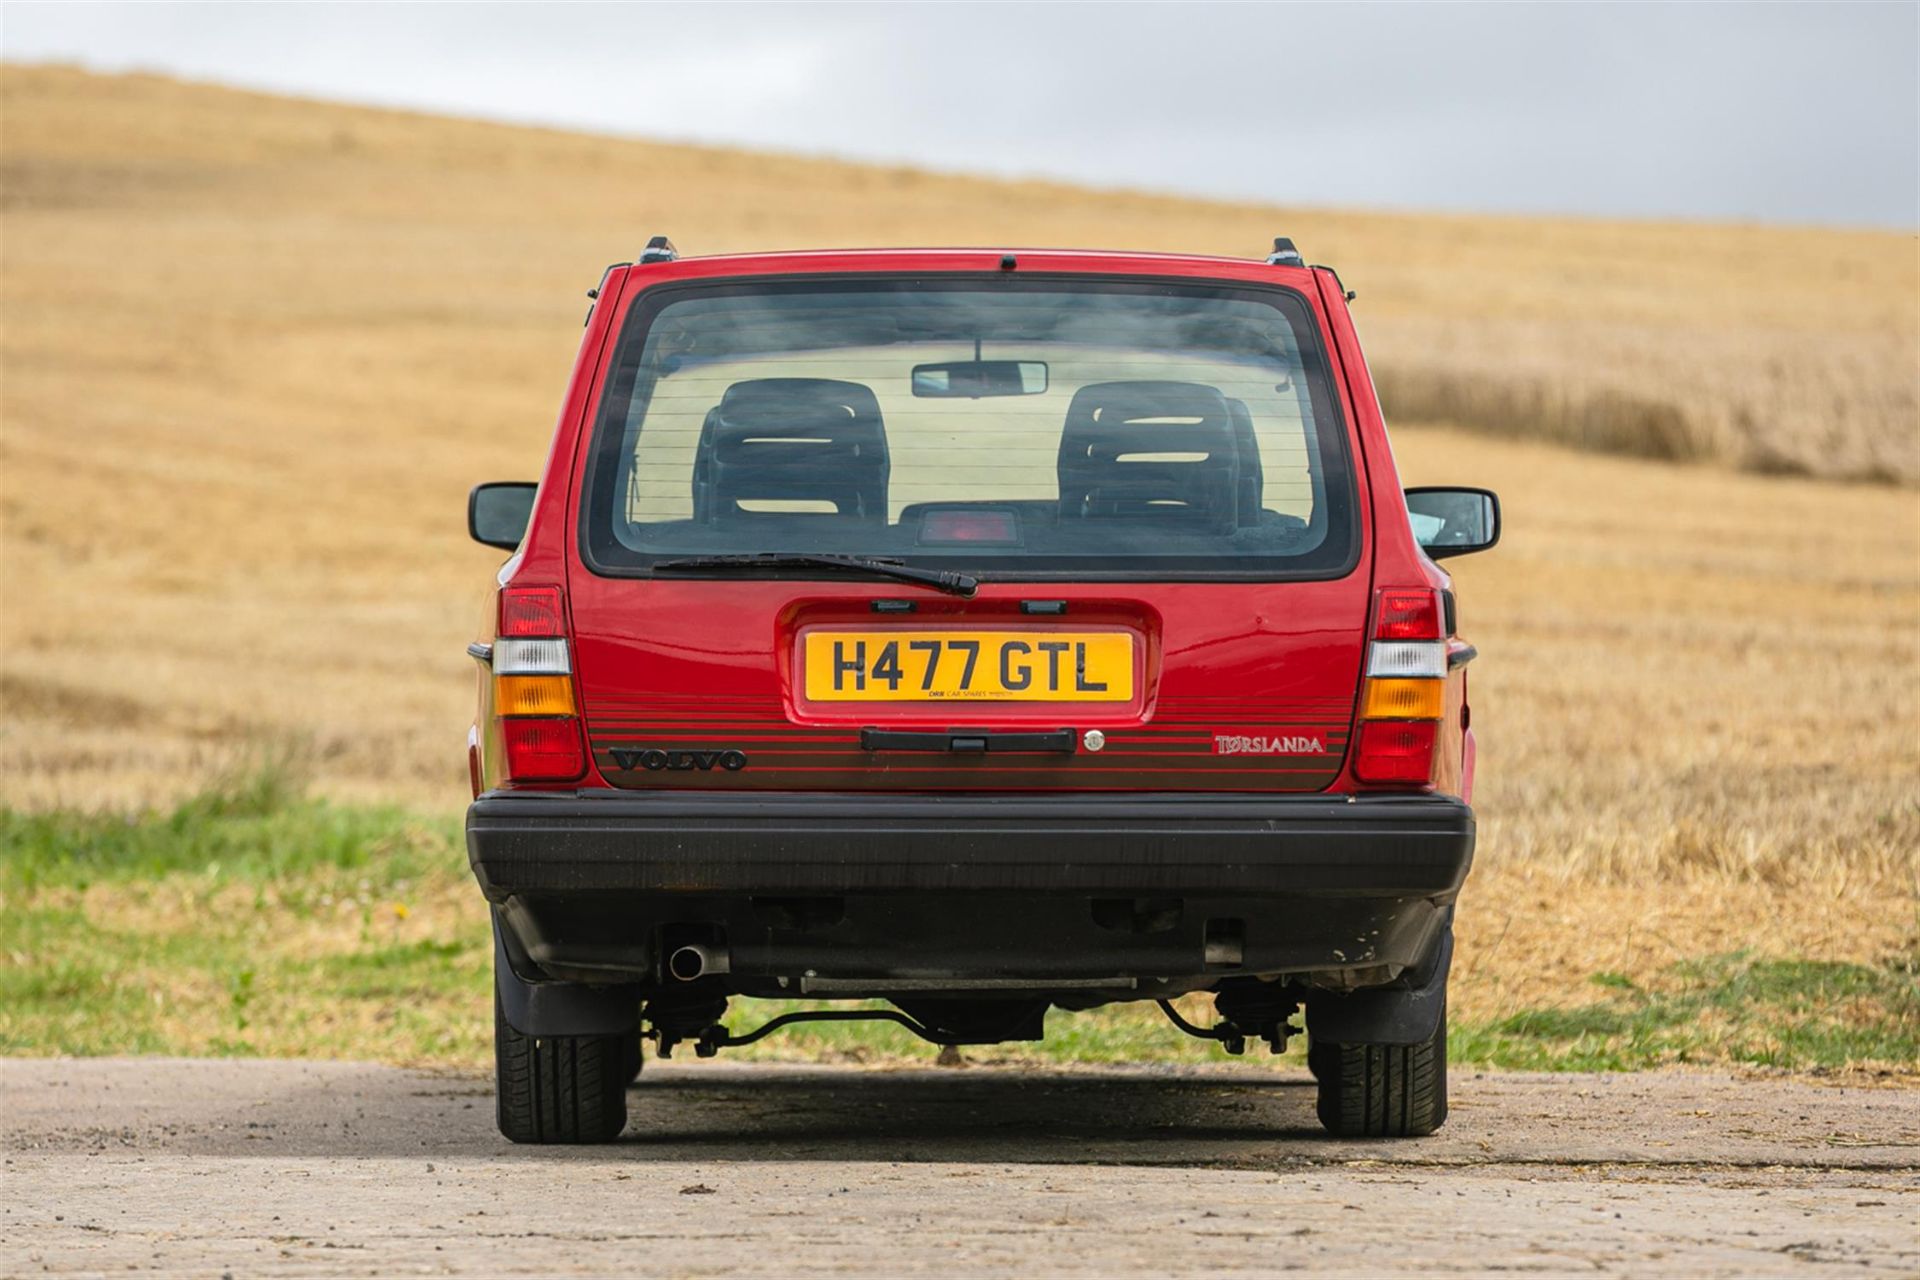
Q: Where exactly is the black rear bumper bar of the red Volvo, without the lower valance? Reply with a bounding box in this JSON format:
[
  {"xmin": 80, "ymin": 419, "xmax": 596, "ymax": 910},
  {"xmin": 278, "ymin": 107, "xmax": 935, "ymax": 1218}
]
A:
[{"xmin": 467, "ymin": 793, "xmax": 1473, "ymax": 902}]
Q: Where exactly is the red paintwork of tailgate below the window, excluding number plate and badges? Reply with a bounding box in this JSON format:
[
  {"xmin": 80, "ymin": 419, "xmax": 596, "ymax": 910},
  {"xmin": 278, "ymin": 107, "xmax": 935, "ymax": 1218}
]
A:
[{"xmin": 570, "ymin": 570, "xmax": 1367, "ymax": 791}]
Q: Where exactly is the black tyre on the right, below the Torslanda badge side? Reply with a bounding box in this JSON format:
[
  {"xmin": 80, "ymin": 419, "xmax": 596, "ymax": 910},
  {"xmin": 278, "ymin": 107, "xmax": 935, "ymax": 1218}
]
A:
[{"xmin": 1308, "ymin": 1006, "xmax": 1446, "ymax": 1138}]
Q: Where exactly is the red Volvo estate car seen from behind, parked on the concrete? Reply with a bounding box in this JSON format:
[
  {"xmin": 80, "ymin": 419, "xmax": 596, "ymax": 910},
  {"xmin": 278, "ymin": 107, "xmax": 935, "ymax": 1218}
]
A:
[{"xmin": 467, "ymin": 238, "xmax": 1500, "ymax": 1142}]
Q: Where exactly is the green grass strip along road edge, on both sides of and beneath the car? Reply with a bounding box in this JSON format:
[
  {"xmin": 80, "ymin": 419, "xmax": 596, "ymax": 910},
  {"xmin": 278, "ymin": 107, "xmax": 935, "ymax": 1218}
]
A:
[{"xmin": 0, "ymin": 768, "xmax": 1920, "ymax": 1073}]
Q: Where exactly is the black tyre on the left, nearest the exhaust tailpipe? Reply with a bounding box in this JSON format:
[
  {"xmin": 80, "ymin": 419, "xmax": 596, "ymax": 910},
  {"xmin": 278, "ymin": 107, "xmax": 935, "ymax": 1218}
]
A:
[{"xmin": 493, "ymin": 996, "xmax": 639, "ymax": 1142}]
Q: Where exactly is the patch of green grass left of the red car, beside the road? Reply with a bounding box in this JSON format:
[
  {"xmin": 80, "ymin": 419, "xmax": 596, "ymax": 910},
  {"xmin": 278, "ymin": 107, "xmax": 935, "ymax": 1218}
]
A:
[{"xmin": 0, "ymin": 768, "xmax": 492, "ymax": 1061}]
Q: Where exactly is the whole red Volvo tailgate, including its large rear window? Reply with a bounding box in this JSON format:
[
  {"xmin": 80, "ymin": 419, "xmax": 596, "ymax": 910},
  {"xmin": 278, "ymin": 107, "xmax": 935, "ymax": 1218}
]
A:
[{"xmin": 568, "ymin": 261, "xmax": 1371, "ymax": 793}]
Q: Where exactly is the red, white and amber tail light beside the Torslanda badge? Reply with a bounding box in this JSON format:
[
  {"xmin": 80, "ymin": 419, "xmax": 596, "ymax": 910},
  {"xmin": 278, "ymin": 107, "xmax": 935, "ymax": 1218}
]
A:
[{"xmin": 1354, "ymin": 587, "xmax": 1446, "ymax": 787}]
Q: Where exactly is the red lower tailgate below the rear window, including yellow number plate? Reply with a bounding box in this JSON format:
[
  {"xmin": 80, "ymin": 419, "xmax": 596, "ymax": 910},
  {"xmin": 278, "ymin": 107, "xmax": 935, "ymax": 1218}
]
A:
[{"xmin": 572, "ymin": 570, "xmax": 1367, "ymax": 793}]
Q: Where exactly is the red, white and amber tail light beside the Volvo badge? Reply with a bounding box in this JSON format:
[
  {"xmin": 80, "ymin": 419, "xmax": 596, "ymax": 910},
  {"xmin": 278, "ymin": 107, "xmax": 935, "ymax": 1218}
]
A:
[{"xmin": 493, "ymin": 587, "xmax": 588, "ymax": 783}]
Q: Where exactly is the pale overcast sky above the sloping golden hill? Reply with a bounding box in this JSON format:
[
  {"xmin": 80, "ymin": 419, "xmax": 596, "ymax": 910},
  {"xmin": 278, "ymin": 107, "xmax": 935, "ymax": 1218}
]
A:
[{"xmin": 0, "ymin": 0, "xmax": 1920, "ymax": 228}]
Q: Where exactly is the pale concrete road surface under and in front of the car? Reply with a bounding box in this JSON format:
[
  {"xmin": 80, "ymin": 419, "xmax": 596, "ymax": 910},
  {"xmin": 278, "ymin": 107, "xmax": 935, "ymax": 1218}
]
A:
[{"xmin": 0, "ymin": 1059, "xmax": 1920, "ymax": 1278}]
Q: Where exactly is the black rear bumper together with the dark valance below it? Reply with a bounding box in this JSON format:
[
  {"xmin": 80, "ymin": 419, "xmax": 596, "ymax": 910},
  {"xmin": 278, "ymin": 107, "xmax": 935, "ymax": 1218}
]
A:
[{"xmin": 467, "ymin": 793, "xmax": 1475, "ymax": 1000}]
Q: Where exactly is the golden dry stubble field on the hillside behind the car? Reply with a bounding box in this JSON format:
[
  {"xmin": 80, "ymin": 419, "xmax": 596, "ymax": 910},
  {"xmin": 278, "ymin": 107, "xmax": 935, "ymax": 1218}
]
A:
[{"xmin": 0, "ymin": 65, "xmax": 1920, "ymax": 1067}]
